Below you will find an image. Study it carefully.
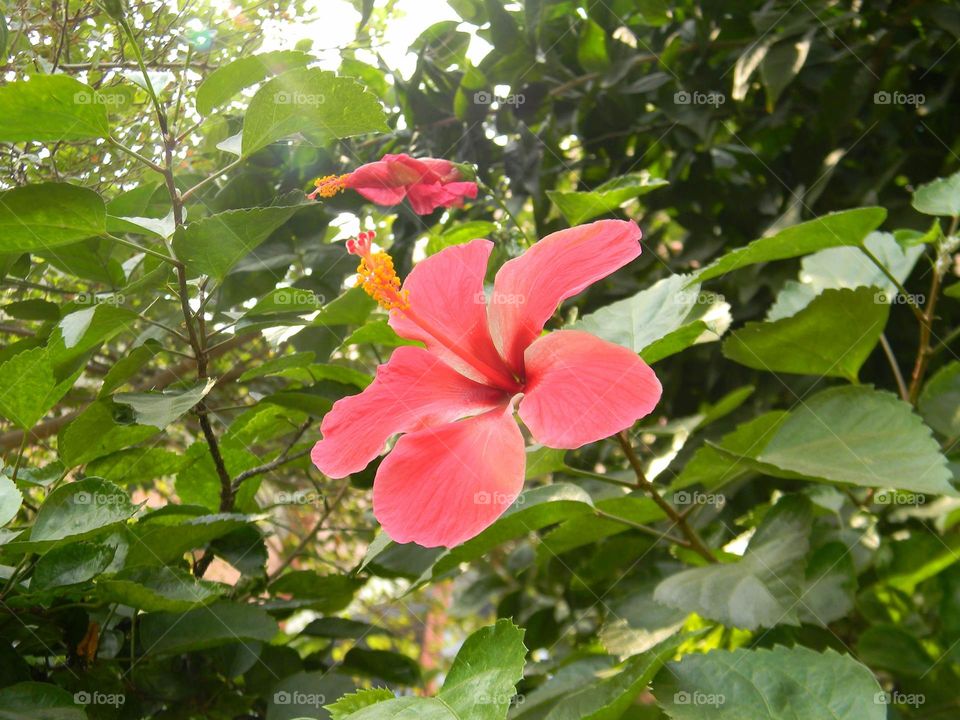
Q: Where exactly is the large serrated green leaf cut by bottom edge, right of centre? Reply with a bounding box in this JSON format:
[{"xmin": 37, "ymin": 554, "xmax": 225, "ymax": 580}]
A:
[{"xmin": 653, "ymin": 646, "xmax": 887, "ymax": 720}]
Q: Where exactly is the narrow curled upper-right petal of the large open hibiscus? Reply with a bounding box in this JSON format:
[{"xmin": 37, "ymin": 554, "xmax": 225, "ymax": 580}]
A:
[{"xmin": 488, "ymin": 220, "xmax": 640, "ymax": 372}]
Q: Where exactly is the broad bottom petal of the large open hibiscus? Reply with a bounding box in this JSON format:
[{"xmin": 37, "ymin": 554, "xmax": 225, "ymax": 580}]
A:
[{"xmin": 373, "ymin": 403, "xmax": 526, "ymax": 547}]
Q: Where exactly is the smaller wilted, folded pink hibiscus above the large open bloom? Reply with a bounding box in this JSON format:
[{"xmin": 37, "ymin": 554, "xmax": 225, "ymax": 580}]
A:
[{"xmin": 307, "ymin": 153, "xmax": 477, "ymax": 215}]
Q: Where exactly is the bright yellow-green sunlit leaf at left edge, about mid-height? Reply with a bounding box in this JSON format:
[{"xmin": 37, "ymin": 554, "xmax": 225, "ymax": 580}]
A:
[{"xmin": 0, "ymin": 347, "xmax": 76, "ymax": 430}]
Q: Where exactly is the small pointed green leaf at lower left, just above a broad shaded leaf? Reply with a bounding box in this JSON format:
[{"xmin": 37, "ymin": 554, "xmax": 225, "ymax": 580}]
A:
[{"xmin": 97, "ymin": 565, "xmax": 222, "ymax": 612}]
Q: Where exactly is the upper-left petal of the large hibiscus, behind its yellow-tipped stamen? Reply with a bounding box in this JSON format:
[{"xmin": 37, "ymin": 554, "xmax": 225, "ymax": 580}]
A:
[{"xmin": 390, "ymin": 240, "xmax": 517, "ymax": 389}]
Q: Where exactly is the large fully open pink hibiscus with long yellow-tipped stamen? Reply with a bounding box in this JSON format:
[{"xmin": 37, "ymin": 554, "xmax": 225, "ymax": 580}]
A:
[{"xmin": 312, "ymin": 220, "xmax": 661, "ymax": 547}]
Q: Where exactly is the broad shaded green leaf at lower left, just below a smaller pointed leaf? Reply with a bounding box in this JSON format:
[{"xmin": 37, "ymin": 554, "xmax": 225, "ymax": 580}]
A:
[{"xmin": 140, "ymin": 602, "xmax": 278, "ymax": 655}]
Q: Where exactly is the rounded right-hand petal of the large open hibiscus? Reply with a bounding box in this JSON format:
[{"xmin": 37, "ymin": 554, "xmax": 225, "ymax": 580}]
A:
[{"xmin": 519, "ymin": 330, "xmax": 661, "ymax": 449}]
